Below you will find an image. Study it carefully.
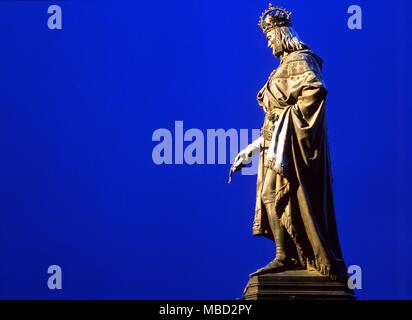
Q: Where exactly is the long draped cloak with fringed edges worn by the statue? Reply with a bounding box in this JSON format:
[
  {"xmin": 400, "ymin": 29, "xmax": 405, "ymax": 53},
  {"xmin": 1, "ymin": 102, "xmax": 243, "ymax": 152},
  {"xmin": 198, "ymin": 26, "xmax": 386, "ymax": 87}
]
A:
[{"xmin": 253, "ymin": 49, "xmax": 346, "ymax": 279}]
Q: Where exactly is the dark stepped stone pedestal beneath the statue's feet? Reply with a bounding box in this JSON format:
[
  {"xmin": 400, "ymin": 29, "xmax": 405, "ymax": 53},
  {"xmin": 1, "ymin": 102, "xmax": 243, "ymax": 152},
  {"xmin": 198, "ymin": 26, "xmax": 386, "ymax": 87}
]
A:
[{"xmin": 242, "ymin": 270, "xmax": 356, "ymax": 300}]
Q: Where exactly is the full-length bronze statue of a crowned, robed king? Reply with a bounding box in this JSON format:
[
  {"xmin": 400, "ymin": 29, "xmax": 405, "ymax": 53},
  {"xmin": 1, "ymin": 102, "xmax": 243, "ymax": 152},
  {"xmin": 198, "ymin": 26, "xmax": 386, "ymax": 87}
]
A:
[{"xmin": 230, "ymin": 4, "xmax": 347, "ymax": 280}]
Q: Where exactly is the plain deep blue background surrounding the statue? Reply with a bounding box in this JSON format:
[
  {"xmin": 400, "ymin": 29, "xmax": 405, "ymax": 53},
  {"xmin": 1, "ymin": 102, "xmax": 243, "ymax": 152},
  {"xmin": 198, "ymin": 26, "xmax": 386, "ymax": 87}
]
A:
[{"xmin": 0, "ymin": 0, "xmax": 412, "ymax": 299}]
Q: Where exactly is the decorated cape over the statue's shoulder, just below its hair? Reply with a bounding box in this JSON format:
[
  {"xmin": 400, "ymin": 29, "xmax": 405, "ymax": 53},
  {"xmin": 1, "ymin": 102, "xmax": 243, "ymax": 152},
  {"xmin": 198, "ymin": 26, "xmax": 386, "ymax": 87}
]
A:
[{"xmin": 282, "ymin": 50, "xmax": 322, "ymax": 77}]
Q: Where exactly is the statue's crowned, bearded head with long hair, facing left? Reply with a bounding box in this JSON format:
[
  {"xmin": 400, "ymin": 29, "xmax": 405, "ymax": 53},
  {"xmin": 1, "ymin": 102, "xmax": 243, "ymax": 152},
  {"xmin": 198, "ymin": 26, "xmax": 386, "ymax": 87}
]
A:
[{"xmin": 259, "ymin": 4, "xmax": 307, "ymax": 57}]
